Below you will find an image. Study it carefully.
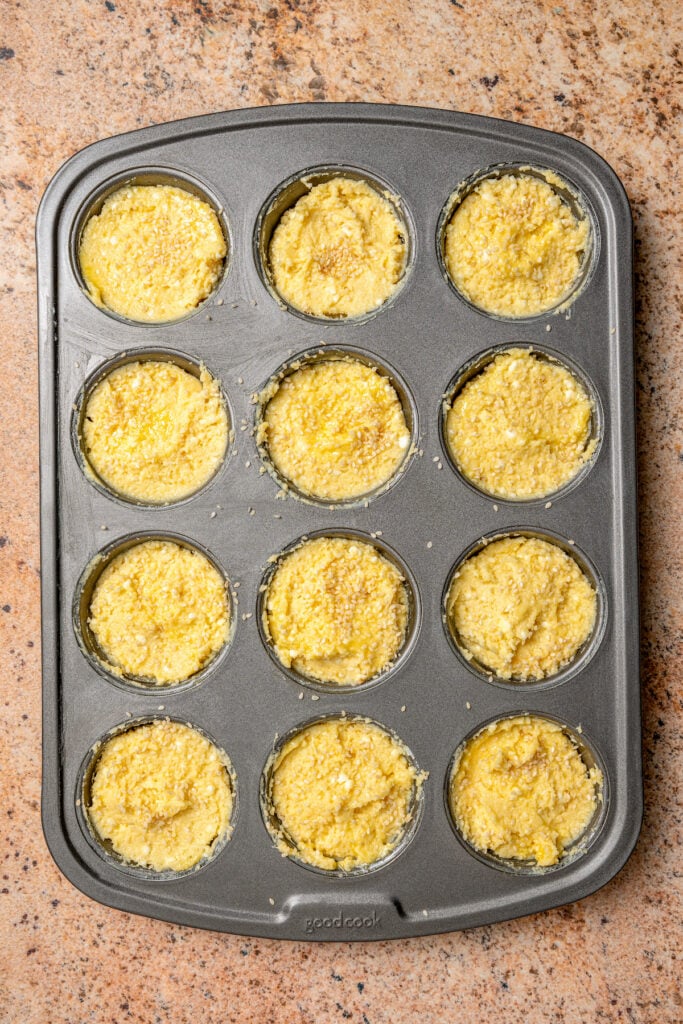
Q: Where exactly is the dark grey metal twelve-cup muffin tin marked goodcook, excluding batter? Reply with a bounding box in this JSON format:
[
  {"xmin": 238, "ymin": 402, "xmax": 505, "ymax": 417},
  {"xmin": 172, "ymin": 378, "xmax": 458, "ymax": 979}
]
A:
[{"xmin": 37, "ymin": 104, "xmax": 642, "ymax": 940}]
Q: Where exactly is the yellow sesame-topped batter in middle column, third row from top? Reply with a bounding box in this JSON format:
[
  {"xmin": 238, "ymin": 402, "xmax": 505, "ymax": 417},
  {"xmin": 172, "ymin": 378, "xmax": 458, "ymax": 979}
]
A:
[{"xmin": 265, "ymin": 537, "xmax": 409, "ymax": 685}]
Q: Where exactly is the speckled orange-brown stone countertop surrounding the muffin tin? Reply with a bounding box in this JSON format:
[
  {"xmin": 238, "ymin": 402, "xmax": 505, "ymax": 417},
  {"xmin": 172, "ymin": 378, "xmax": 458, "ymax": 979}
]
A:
[{"xmin": 0, "ymin": 0, "xmax": 683, "ymax": 1024}]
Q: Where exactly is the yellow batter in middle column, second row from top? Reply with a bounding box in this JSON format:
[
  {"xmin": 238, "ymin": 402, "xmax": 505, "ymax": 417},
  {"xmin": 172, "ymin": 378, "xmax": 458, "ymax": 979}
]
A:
[{"xmin": 257, "ymin": 359, "xmax": 411, "ymax": 501}]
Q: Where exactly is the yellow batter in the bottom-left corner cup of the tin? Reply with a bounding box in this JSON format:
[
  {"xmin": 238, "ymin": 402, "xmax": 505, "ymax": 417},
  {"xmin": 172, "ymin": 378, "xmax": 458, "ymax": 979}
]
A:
[{"xmin": 87, "ymin": 721, "xmax": 232, "ymax": 871}]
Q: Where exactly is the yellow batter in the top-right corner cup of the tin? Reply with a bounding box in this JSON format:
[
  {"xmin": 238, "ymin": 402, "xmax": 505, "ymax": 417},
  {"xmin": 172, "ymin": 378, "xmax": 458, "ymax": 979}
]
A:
[{"xmin": 444, "ymin": 172, "xmax": 590, "ymax": 316}]
